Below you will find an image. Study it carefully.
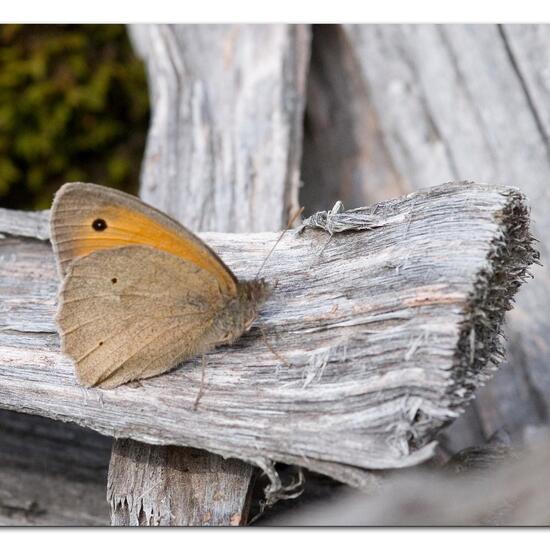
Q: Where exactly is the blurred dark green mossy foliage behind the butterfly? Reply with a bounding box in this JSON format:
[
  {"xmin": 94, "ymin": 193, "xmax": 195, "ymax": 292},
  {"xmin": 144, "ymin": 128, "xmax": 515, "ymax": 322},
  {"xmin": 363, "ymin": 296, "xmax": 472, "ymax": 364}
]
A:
[{"xmin": 0, "ymin": 25, "xmax": 149, "ymax": 209}]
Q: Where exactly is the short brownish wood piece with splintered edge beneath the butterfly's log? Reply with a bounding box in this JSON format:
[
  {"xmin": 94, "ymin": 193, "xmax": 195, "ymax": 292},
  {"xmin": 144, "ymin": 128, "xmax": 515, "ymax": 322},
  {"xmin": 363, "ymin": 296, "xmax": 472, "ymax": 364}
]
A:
[{"xmin": 107, "ymin": 439, "xmax": 254, "ymax": 526}]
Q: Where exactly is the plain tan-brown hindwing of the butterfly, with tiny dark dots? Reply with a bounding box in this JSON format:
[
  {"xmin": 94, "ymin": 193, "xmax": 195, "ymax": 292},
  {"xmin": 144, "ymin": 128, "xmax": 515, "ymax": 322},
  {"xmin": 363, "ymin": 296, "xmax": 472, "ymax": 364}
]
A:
[{"xmin": 57, "ymin": 246, "xmax": 227, "ymax": 388}]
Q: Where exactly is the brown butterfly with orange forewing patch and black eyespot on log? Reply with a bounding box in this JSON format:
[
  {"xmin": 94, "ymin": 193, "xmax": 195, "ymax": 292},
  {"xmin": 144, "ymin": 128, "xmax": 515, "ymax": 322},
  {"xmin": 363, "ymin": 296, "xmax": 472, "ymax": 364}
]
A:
[{"xmin": 50, "ymin": 183, "xmax": 271, "ymax": 388}]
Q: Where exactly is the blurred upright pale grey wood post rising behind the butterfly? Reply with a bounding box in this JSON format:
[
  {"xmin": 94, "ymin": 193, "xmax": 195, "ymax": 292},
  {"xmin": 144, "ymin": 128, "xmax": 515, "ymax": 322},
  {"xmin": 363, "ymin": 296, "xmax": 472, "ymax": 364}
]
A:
[{"xmin": 130, "ymin": 25, "xmax": 310, "ymax": 232}]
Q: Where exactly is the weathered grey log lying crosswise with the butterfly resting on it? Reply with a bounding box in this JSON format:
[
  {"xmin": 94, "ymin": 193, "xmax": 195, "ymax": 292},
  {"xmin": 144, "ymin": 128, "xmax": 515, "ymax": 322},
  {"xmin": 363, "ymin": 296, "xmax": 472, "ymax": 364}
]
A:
[{"xmin": 0, "ymin": 183, "xmax": 536, "ymax": 487}]
